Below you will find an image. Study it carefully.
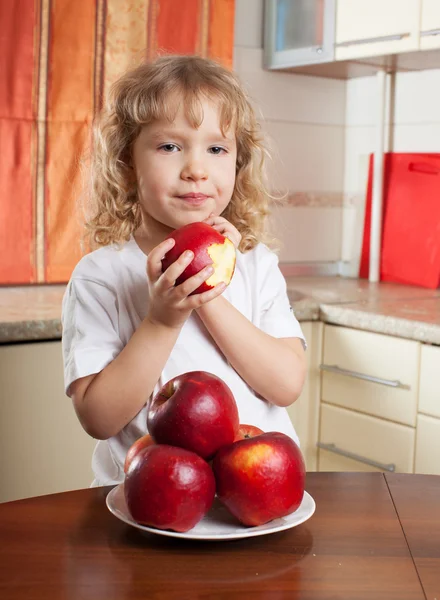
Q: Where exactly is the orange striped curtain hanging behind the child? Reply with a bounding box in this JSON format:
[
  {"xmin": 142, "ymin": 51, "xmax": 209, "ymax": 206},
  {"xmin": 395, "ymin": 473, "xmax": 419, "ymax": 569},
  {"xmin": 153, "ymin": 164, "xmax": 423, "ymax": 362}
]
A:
[{"xmin": 0, "ymin": 0, "xmax": 235, "ymax": 285}]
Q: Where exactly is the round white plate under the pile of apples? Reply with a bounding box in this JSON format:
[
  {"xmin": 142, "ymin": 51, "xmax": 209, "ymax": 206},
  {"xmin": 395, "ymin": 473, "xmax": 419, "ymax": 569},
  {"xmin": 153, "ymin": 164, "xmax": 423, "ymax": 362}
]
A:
[{"xmin": 106, "ymin": 483, "xmax": 316, "ymax": 541}]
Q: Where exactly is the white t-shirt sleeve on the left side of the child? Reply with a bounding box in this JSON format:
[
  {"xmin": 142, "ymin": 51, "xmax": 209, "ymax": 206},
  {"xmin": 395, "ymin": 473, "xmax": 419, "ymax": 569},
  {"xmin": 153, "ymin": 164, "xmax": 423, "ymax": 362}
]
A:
[{"xmin": 61, "ymin": 278, "xmax": 123, "ymax": 396}]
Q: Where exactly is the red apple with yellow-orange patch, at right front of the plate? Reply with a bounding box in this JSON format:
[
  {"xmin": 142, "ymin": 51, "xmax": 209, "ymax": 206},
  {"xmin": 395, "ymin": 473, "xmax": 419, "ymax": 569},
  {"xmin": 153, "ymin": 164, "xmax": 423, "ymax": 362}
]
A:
[{"xmin": 212, "ymin": 432, "xmax": 305, "ymax": 526}]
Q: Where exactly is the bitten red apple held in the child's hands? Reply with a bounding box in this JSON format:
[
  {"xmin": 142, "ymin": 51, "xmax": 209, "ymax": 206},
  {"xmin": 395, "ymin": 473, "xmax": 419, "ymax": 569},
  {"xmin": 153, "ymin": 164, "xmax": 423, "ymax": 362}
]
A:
[{"xmin": 162, "ymin": 222, "xmax": 235, "ymax": 295}]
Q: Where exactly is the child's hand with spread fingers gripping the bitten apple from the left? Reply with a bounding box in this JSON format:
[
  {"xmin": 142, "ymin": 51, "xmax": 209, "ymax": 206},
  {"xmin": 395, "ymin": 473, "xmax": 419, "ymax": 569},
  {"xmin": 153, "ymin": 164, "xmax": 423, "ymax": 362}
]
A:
[{"xmin": 147, "ymin": 239, "xmax": 226, "ymax": 328}]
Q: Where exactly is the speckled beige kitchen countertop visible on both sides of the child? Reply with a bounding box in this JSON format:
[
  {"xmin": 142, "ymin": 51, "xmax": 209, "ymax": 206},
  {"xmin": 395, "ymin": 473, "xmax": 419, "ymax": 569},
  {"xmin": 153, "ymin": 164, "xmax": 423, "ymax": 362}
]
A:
[{"xmin": 0, "ymin": 276, "xmax": 440, "ymax": 345}]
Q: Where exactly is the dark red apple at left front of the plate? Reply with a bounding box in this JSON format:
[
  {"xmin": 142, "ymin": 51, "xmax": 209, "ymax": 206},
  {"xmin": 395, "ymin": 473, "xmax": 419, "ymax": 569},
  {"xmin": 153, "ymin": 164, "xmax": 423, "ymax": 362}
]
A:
[{"xmin": 124, "ymin": 444, "xmax": 215, "ymax": 532}]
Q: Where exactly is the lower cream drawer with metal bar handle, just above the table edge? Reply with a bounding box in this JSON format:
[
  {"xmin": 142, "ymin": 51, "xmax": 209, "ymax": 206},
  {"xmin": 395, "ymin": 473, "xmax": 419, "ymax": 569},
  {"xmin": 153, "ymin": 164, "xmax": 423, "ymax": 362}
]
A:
[{"xmin": 318, "ymin": 403, "xmax": 415, "ymax": 473}]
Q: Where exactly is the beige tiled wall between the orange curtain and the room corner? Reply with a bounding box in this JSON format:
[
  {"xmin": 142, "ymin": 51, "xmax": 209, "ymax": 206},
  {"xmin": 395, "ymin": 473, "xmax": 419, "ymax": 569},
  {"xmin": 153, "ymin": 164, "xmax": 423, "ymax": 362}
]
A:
[{"xmin": 234, "ymin": 0, "xmax": 346, "ymax": 263}]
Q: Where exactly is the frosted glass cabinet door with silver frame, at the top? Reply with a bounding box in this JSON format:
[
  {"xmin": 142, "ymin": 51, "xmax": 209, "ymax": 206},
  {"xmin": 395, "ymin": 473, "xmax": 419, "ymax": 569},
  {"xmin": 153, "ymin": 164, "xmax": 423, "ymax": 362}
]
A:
[{"xmin": 264, "ymin": 0, "xmax": 335, "ymax": 69}]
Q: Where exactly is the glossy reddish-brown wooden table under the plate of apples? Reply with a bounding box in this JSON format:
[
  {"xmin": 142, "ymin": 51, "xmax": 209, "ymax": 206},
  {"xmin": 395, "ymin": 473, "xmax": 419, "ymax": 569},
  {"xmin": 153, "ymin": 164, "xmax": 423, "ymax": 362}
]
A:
[{"xmin": 0, "ymin": 473, "xmax": 440, "ymax": 600}]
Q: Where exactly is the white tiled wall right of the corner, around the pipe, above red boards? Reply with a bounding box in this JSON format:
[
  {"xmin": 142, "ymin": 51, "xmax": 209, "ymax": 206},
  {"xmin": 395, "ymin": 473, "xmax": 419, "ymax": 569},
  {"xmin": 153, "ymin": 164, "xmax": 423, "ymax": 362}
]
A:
[{"xmin": 342, "ymin": 69, "xmax": 440, "ymax": 276}]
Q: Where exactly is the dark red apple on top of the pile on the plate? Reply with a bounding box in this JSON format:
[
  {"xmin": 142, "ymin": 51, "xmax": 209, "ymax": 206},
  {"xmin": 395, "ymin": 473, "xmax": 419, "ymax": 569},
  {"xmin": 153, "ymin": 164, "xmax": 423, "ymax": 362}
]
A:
[{"xmin": 147, "ymin": 371, "xmax": 239, "ymax": 459}]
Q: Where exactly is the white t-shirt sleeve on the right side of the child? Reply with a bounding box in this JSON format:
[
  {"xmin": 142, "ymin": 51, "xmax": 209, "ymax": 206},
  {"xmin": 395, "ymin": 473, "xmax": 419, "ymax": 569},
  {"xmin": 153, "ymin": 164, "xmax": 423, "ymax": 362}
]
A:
[{"xmin": 258, "ymin": 248, "xmax": 307, "ymax": 349}]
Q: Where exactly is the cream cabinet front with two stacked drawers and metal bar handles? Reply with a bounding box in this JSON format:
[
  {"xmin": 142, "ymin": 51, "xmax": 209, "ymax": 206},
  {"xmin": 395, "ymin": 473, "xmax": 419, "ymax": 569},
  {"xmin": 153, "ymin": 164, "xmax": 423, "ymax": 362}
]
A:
[{"xmin": 318, "ymin": 325, "xmax": 421, "ymax": 473}]
